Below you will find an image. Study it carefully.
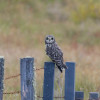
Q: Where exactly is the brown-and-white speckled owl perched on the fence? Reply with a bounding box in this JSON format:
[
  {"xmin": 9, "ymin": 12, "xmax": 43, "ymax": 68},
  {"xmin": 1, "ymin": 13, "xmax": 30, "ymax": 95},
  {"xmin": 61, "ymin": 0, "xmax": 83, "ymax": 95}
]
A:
[{"xmin": 45, "ymin": 35, "xmax": 67, "ymax": 73}]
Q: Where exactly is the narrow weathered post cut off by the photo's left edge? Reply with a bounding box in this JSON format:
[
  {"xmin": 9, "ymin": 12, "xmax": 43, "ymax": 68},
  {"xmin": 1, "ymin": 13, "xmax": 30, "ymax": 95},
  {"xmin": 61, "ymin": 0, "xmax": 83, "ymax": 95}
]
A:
[{"xmin": 0, "ymin": 58, "xmax": 4, "ymax": 100}]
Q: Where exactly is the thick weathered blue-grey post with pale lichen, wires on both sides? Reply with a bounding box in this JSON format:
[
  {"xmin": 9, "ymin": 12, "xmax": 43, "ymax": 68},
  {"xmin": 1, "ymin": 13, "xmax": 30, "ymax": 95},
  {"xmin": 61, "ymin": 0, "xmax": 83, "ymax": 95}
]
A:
[{"xmin": 20, "ymin": 58, "xmax": 35, "ymax": 100}]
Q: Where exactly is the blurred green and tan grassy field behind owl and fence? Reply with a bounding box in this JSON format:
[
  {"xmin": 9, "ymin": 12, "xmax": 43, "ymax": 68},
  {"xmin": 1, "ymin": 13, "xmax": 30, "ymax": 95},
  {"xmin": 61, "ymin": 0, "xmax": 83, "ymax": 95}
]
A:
[{"xmin": 0, "ymin": 0, "xmax": 100, "ymax": 100}]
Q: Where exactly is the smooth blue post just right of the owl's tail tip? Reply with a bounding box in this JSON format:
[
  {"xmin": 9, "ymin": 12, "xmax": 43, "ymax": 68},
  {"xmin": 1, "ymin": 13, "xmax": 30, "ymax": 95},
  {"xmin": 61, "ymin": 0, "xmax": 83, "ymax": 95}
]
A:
[{"xmin": 65, "ymin": 62, "xmax": 75, "ymax": 100}]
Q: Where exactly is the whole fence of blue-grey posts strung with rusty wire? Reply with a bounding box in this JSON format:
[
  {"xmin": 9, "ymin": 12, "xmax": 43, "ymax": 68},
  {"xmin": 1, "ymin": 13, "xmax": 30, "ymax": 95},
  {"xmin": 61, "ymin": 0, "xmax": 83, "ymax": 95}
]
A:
[{"xmin": 0, "ymin": 58, "xmax": 100, "ymax": 100}]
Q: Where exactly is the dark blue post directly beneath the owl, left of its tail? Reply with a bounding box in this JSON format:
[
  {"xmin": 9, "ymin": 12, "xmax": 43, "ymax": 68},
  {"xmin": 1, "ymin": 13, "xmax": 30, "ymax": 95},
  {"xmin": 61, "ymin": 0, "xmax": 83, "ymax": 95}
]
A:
[{"xmin": 43, "ymin": 62, "xmax": 55, "ymax": 100}]
